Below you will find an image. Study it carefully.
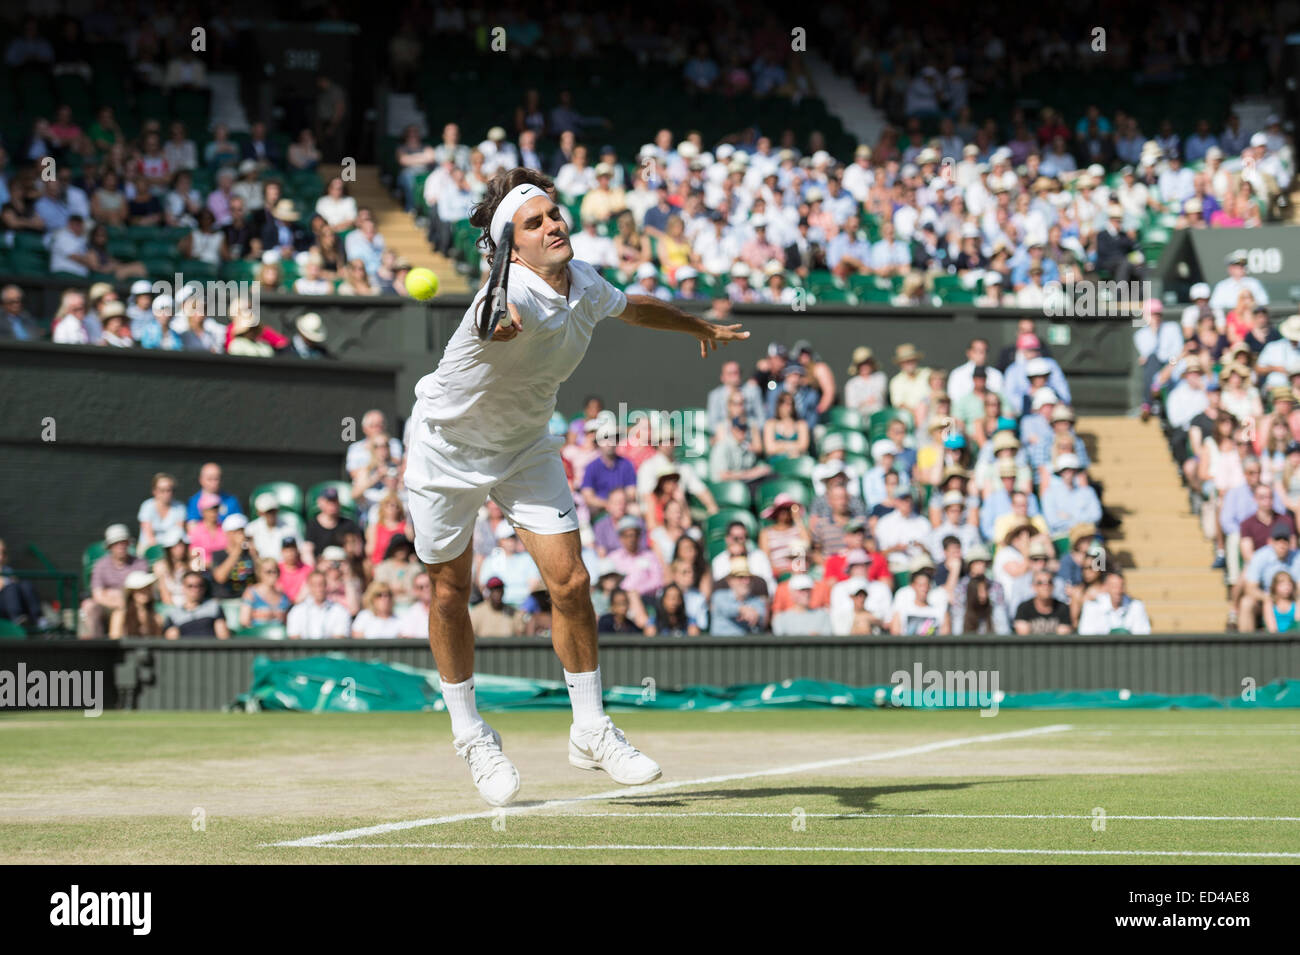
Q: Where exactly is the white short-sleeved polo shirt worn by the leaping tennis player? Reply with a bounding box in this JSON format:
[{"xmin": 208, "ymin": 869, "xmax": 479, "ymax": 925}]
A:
[{"xmin": 415, "ymin": 259, "xmax": 628, "ymax": 452}]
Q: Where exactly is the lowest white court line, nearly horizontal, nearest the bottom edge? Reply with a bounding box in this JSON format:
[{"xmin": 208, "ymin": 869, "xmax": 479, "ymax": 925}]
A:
[{"xmin": 292, "ymin": 841, "xmax": 1300, "ymax": 859}]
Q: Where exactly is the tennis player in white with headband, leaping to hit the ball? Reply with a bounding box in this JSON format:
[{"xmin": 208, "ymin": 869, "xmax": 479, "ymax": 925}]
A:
[{"xmin": 406, "ymin": 169, "xmax": 749, "ymax": 806}]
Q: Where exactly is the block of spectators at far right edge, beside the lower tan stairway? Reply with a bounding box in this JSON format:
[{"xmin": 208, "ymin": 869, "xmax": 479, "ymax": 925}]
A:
[{"xmin": 1159, "ymin": 261, "xmax": 1300, "ymax": 633}]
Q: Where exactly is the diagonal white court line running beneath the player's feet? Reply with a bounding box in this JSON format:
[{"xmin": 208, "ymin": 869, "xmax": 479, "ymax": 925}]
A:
[{"xmin": 263, "ymin": 722, "xmax": 1074, "ymax": 848}]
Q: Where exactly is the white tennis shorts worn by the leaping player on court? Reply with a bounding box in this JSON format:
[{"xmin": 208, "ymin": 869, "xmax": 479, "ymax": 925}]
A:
[{"xmin": 406, "ymin": 422, "xmax": 579, "ymax": 564}]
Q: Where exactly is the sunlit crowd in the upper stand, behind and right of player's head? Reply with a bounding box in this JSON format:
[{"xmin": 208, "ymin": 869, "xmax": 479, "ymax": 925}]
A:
[{"xmin": 410, "ymin": 92, "xmax": 1294, "ymax": 308}]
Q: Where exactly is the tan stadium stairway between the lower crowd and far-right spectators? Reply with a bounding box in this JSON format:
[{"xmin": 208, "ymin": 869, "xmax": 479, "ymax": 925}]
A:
[{"xmin": 1078, "ymin": 417, "xmax": 1227, "ymax": 633}]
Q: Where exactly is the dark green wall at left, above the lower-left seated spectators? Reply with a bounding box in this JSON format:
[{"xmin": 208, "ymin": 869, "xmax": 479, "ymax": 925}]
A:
[{"xmin": 0, "ymin": 343, "xmax": 397, "ymax": 569}]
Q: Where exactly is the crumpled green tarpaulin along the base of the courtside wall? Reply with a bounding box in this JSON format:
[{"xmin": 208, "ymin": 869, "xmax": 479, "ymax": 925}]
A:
[{"xmin": 230, "ymin": 654, "xmax": 1300, "ymax": 713}]
